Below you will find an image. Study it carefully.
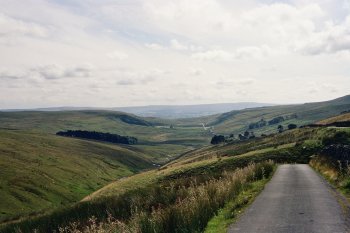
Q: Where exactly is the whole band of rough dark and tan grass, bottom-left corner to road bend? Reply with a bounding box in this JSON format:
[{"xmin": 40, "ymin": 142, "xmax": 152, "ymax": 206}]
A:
[{"xmin": 1, "ymin": 161, "xmax": 274, "ymax": 233}]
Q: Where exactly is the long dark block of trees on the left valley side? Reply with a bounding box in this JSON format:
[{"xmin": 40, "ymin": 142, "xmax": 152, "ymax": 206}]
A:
[{"xmin": 56, "ymin": 130, "xmax": 137, "ymax": 144}]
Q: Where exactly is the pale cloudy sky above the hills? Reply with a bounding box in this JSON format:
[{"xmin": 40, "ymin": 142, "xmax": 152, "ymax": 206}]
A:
[{"xmin": 0, "ymin": 0, "xmax": 350, "ymax": 109}]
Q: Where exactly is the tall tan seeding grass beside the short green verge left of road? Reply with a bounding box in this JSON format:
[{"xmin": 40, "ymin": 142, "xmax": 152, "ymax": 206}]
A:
[{"xmin": 49, "ymin": 161, "xmax": 274, "ymax": 233}]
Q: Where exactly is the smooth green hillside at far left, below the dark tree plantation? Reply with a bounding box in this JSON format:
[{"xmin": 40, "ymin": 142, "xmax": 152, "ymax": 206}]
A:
[{"xmin": 0, "ymin": 130, "xmax": 152, "ymax": 221}]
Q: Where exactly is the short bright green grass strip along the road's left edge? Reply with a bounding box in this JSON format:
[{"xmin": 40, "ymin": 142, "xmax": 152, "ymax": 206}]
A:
[{"xmin": 204, "ymin": 172, "xmax": 272, "ymax": 233}]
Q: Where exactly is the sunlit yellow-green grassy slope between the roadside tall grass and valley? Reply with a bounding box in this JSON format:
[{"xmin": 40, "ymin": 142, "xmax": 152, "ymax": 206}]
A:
[{"xmin": 80, "ymin": 126, "xmax": 322, "ymax": 200}]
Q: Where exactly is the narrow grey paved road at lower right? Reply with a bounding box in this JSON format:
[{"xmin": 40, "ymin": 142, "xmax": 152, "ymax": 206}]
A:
[{"xmin": 228, "ymin": 164, "xmax": 349, "ymax": 233}]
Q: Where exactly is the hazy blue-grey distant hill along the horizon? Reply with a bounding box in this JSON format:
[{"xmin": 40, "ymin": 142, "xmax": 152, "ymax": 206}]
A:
[{"xmin": 1, "ymin": 102, "xmax": 272, "ymax": 119}]
